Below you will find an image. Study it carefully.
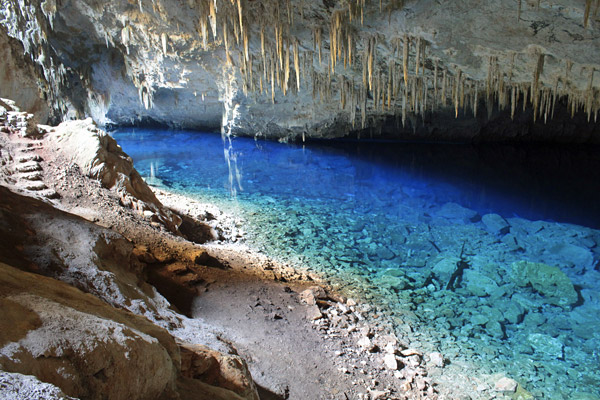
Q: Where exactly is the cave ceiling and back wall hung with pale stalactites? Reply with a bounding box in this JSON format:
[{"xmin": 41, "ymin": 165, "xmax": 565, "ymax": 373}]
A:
[{"xmin": 0, "ymin": 0, "xmax": 600, "ymax": 142}]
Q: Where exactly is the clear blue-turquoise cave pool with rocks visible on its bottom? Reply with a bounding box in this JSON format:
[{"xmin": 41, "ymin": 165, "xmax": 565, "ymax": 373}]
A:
[{"xmin": 114, "ymin": 129, "xmax": 600, "ymax": 399}]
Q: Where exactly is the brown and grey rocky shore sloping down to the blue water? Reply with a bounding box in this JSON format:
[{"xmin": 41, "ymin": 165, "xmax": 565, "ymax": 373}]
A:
[{"xmin": 0, "ymin": 101, "xmax": 450, "ymax": 399}]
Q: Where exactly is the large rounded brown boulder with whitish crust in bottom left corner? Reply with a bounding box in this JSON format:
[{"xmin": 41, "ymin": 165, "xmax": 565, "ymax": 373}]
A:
[{"xmin": 0, "ymin": 263, "xmax": 180, "ymax": 399}]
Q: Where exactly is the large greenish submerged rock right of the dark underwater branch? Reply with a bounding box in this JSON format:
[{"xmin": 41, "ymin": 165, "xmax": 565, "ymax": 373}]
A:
[{"xmin": 512, "ymin": 261, "xmax": 578, "ymax": 307}]
